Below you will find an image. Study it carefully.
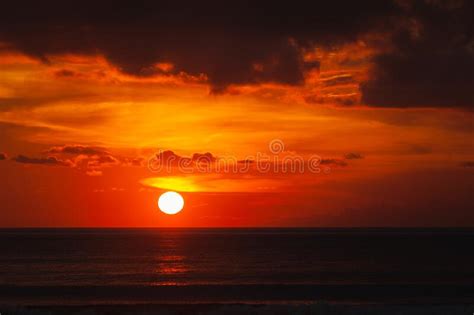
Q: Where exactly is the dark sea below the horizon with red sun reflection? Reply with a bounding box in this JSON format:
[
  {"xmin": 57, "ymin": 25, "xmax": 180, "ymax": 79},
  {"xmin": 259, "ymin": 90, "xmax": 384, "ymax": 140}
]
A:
[{"xmin": 0, "ymin": 229, "xmax": 474, "ymax": 302}]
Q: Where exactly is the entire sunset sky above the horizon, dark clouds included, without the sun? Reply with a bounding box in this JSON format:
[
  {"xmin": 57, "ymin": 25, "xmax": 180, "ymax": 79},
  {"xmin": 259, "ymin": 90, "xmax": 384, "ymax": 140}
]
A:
[{"xmin": 0, "ymin": 0, "xmax": 474, "ymax": 227}]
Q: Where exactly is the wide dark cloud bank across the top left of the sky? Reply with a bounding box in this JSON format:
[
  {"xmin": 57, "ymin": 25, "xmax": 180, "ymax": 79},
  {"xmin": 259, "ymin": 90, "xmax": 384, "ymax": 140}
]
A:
[{"xmin": 0, "ymin": 0, "xmax": 400, "ymax": 92}]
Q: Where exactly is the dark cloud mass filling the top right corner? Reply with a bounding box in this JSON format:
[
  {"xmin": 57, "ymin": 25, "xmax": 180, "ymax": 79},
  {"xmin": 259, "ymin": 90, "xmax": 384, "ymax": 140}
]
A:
[{"xmin": 361, "ymin": 1, "xmax": 474, "ymax": 108}]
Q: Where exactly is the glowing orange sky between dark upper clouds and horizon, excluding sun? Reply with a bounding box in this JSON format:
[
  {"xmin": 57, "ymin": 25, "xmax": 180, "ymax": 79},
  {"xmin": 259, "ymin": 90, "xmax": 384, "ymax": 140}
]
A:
[{"xmin": 0, "ymin": 2, "xmax": 474, "ymax": 227}]
